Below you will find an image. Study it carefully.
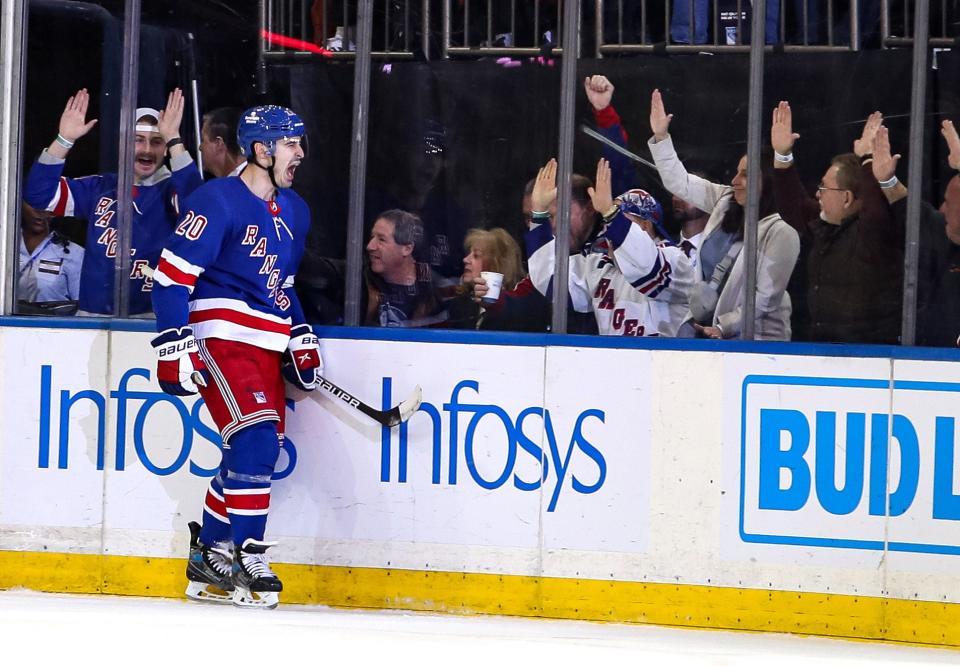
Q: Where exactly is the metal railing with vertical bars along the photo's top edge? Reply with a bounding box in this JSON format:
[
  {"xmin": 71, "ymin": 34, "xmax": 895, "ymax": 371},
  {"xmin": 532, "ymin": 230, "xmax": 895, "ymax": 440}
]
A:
[{"xmin": 261, "ymin": 0, "xmax": 960, "ymax": 59}]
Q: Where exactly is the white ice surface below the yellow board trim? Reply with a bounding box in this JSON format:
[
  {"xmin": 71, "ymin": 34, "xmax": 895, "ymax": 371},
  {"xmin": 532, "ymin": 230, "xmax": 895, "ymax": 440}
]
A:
[{"xmin": 0, "ymin": 590, "xmax": 960, "ymax": 666}]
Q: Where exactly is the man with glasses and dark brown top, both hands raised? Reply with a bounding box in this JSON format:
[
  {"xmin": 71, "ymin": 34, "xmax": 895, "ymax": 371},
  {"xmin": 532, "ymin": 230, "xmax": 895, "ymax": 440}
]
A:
[{"xmin": 770, "ymin": 102, "xmax": 904, "ymax": 344}]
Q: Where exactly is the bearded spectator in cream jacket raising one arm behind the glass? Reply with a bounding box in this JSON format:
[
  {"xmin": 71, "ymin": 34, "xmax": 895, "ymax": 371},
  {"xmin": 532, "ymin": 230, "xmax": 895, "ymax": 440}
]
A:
[{"xmin": 648, "ymin": 90, "xmax": 800, "ymax": 340}]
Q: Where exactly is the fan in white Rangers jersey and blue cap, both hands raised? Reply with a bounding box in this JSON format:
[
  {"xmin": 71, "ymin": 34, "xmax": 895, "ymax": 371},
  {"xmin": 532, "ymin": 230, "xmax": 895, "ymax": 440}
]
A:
[{"xmin": 526, "ymin": 160, "xmax": 694, "ymax": 336}]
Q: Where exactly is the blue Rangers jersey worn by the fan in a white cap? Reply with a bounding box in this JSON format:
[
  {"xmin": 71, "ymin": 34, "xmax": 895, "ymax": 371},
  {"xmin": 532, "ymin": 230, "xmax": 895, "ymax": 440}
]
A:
[{"xmin": 24, "ymin": 151, "xmax": 203, "ymax": 314}]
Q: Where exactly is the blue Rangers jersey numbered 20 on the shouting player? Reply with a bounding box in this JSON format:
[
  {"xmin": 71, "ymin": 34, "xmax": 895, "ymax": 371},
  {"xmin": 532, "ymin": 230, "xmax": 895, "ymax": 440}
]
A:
[{"xmin": 153, "ymin": 178, "xmax": 310, "ymax": 351}]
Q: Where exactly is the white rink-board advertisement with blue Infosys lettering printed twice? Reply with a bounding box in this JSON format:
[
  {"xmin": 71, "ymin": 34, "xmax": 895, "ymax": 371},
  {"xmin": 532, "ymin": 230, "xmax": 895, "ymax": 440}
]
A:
[{"xmin": 0, "ymin": 329, "xmax": 650, "ymax": 559}]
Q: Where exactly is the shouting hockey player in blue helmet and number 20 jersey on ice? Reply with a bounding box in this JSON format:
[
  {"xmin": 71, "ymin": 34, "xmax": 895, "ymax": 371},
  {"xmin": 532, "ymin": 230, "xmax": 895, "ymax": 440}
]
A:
[{"xmin": 152, "ymin": 106, "xmax": 323, "ymax": 608}]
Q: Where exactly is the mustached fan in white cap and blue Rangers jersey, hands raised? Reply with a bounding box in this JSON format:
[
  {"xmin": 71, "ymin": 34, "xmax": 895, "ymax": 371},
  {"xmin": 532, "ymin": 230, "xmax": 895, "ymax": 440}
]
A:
[{"xmin": 24, "ymin": 88, "xmax": 203, "ymax": 315}]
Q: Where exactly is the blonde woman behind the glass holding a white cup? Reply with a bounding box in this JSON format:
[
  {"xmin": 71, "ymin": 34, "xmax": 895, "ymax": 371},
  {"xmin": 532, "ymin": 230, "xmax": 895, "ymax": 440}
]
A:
[{"xmin": 451, "ymin": 228, "xmax": 550, "ymax": 333}]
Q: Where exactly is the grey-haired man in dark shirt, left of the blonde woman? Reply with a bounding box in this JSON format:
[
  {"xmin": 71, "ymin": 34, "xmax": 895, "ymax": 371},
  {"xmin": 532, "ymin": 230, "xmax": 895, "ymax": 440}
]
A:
[{"xmin": 364, "ymin": 209, "xmax": 453, "ymax": 327}]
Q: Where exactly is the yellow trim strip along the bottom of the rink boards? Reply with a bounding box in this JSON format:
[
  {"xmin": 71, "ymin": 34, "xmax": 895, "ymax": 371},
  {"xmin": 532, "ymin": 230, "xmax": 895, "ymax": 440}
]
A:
[{"xmin": 0, "ymin": 551, "xmax": 960, "ymax": 647}]
